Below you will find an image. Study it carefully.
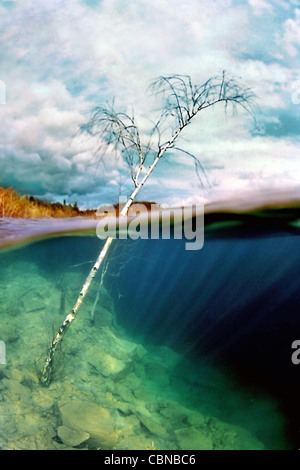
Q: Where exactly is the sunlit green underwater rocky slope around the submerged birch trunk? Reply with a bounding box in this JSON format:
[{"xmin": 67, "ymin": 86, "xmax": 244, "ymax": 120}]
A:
[{"xmin": 0, "ymin": 242, "xmax": 289, "ymax": 450}]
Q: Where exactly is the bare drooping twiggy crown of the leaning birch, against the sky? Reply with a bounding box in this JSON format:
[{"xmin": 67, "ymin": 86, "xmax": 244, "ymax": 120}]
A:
[{"xmin": 81, "ymin": 71, "xmax": 254, "ymax": 195}]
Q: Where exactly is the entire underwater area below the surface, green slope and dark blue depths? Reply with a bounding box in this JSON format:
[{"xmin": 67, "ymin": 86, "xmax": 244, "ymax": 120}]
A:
[{"xmin": 0, "ymin": 212, "xmax": 300, "ymax": 450}]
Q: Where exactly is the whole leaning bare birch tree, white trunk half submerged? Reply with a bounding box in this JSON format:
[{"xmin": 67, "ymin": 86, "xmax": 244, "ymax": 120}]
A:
[{"xmin": 41, "ymin": 72, "xmax": 254, "ymax": 386}]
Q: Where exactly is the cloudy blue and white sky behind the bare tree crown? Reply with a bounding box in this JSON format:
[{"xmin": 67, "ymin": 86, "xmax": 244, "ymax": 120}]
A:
[{"xmin": 0, "ymin": 0, "xmax": 300, "ymax": 208}]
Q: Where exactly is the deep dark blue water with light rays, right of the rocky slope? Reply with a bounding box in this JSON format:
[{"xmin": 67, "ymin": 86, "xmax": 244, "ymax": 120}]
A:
[{"xmin": 113, "ymin": 234, "xmax": 300, "ymax": 445}]
